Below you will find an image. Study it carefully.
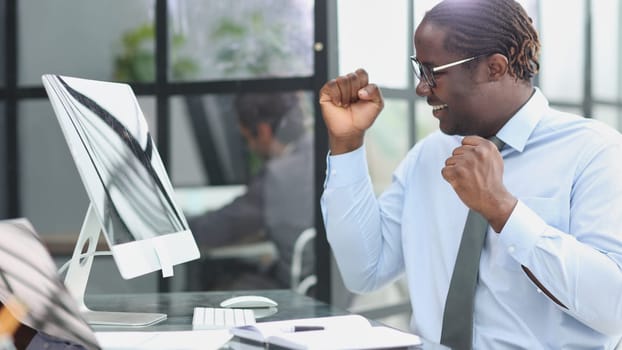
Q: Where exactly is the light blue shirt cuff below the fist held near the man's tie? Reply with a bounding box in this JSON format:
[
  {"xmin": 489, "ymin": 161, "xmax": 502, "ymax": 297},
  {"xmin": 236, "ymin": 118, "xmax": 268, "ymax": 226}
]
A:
[{"xmin": 499, "ymin": 200, "xmax": 548, "ymax": 265}]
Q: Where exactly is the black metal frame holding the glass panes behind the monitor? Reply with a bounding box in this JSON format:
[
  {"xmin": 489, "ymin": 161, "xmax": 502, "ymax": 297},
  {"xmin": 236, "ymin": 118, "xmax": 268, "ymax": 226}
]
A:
[{"xmin": 0, "ymin": 0, "xmax": 330, "ymax": 302}]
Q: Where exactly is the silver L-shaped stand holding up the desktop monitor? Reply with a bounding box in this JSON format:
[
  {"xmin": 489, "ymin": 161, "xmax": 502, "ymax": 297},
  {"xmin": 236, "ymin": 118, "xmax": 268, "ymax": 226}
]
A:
[{"xmin": 65, "ymin": 203, "xmax": 166, "ymax": 327}]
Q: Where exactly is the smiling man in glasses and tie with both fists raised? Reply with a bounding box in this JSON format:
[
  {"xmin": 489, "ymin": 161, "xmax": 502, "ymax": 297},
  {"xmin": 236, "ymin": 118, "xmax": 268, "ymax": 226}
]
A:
[{"xmin": 320, "ymin": 0, "xmax": 622, "ymax": 349}]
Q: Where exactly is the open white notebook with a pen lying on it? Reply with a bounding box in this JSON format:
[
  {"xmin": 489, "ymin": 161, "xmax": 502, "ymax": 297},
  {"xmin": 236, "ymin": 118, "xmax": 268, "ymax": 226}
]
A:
[{"xmin": 230, "ymin": 315, "xmax": 421, "ymax": 350}]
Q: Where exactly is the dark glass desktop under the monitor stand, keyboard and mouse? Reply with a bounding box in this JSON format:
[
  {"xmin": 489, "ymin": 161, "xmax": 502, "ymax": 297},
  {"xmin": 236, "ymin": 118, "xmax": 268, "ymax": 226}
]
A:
[{"xmin": 86, "ymin": 289, "xmax": 448, "ymax": 350}]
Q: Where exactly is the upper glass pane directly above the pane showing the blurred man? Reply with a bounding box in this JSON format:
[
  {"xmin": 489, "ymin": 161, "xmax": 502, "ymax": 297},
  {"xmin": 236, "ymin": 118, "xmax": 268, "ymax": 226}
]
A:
[{"xmin": 168, "ymin": 0, "xmax": 314, "ymax": 81}]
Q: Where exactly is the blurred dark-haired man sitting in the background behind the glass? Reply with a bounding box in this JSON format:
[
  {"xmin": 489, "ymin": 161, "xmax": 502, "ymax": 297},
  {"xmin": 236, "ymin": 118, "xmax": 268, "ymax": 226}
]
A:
[{"xmin": 189, "ymin": 93, "xmax": 313, "ymax": 289}]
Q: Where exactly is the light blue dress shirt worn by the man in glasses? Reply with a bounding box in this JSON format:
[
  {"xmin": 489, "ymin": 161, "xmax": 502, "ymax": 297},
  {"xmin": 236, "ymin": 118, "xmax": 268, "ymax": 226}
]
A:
[{"xmin": 321, "ymin": 89, "xmax": 622, "ymax": 349}]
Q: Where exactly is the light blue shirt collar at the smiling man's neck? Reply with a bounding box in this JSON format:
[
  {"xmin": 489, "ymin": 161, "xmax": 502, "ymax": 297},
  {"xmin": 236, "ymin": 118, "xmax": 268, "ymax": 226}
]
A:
[{"xmin": 497, "ymin": 87, "xmax": 549, "ymax": 152}]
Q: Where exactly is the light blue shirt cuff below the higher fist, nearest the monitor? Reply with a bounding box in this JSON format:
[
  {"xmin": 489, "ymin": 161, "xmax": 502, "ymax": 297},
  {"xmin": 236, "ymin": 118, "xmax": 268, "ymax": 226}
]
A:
[{"xmin": 324, "ymin": 145, "xmax": 367, "ymax": 188}]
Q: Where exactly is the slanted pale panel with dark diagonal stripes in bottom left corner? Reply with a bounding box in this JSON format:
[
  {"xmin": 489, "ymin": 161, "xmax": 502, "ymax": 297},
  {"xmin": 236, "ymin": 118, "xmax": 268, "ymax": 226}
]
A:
[{"xmin": 0, "ymin": 219, "xmax": 99, "ymax": 349}]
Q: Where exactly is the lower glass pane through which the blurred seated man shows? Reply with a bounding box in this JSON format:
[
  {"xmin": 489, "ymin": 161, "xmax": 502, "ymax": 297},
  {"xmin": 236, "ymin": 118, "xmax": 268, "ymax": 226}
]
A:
[{"xmin": 170, "ymin": 91, "xmax": 315, "ymax": 293}]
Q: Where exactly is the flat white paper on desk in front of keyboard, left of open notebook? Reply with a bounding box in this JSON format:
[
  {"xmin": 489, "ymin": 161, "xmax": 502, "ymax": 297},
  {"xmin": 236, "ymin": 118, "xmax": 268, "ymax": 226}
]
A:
[{"xmin": 95, "ymin": 329, "xmax": 233, "ymax": 350}]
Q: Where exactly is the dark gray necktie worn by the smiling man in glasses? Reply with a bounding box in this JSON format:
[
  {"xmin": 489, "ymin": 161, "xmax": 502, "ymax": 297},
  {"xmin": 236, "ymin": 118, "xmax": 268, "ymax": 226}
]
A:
[{"xmin": 441, "ymin": 136, "xmax": 504, "ymax": 350}]
